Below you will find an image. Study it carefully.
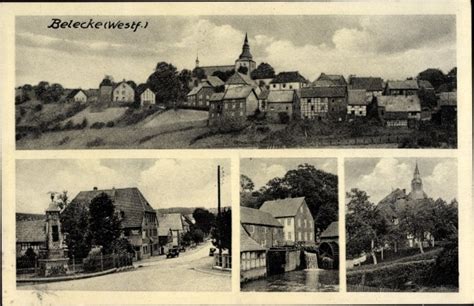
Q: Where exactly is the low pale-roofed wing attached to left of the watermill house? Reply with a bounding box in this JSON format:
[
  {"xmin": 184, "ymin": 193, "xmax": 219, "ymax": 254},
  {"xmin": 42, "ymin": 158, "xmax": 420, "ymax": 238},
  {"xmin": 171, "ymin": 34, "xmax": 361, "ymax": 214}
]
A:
[{"xmin": 240, "ymin": 207, "xmax": 284, "ymax": 248}]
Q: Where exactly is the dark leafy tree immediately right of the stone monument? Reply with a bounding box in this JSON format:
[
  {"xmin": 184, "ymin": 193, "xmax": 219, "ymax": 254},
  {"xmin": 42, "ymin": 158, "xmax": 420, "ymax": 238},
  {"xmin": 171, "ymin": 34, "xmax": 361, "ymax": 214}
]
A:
[{"xmin": 60, "ymin": 202, "xmax": 91, "ymax": 258}]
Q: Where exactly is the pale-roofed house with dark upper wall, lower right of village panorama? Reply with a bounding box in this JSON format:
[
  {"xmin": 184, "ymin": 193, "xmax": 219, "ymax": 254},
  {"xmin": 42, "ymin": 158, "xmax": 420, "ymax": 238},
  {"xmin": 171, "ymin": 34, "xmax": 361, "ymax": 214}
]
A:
[{"xmin": 377, "ymin": 96, "xmax": 421, "ymax": 127}]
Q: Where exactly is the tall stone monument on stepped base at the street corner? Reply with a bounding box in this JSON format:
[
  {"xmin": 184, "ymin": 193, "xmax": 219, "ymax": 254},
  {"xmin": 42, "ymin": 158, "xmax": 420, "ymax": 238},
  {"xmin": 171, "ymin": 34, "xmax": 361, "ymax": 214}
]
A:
[{"xmin": 38, "ymin": 194, "xmax": 69, "ymax": 276}]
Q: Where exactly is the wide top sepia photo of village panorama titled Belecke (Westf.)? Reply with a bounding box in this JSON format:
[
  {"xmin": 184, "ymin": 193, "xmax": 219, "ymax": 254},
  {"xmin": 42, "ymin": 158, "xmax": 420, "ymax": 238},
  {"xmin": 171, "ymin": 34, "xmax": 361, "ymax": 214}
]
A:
[{"xmin": 15, "ymin": 15, "xmax": 458, "ymax": 150}]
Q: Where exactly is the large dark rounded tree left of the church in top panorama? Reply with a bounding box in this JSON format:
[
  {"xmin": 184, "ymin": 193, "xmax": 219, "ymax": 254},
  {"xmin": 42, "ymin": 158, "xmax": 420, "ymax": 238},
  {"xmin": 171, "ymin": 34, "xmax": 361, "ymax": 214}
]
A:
[{"xmin": 147, "ymin": 62, "xmax": 181, "ymax": 107}]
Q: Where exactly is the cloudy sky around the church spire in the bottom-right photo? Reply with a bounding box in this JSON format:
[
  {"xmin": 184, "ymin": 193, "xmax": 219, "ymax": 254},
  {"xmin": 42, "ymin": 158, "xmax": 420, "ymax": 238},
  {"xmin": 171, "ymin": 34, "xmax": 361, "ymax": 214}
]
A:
[{"xmin": 344, "ymin": 158, "xmax": 458, "ymax": 203}]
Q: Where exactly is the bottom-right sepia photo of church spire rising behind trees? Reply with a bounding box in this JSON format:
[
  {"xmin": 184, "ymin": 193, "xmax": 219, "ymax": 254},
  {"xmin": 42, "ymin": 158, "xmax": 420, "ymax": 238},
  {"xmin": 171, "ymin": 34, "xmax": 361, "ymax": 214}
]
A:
[{"xmin": 345, "ymin": 157, "xmax": 459, "ymax": 292}]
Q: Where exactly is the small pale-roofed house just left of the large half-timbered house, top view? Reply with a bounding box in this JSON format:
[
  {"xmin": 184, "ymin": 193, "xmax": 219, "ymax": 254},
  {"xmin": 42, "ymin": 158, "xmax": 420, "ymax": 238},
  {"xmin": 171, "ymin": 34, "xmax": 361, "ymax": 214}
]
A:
[{"xmin": 261, "ymin": 90, "xmax": 300, "ymax": 123}]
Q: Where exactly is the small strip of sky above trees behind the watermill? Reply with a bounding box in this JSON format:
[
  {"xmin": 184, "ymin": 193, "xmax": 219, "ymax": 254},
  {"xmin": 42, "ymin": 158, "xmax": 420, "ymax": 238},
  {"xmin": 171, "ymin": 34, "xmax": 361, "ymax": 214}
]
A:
[{"xmin": 240, "ymin": 158, "xmax": 337, "ymax": 190}]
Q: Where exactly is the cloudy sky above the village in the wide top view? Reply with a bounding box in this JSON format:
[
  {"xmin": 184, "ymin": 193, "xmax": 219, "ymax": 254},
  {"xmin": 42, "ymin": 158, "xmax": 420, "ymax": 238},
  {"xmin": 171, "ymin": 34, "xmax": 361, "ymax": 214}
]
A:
[{"xmin": 15, "ymin": 15, "xmax": 456, "ymax": 88}]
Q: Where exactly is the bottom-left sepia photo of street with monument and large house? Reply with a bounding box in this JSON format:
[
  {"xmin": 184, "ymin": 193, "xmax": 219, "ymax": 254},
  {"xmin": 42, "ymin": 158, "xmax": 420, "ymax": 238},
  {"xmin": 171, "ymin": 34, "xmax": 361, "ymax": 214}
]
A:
[{"xmin": 15, "ymin": 159, "xmax": 232, "ymax": 291}]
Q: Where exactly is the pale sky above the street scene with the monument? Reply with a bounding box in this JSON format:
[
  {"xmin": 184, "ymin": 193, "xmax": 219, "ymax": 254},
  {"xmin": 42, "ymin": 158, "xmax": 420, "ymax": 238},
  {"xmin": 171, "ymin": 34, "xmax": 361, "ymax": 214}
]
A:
[{"xmin": 16, "ymin": 159, "xmax": 231, "ymax": 213}]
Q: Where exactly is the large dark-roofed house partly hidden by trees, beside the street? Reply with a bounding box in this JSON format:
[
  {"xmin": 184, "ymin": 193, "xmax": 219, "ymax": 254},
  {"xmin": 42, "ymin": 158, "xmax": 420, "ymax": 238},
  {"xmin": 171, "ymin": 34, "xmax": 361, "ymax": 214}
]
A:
[{"xmin": 71, "ymin": 187, "xmax": 159, "ymax": 260}]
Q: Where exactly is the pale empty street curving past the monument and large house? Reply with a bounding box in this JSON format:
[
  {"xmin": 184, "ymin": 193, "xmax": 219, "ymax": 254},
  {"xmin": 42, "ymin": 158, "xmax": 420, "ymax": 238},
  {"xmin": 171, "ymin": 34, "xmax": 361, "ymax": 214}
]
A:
[{"xmin": 18, "ymin": 242, "xmax": 231, "ymax": 291}]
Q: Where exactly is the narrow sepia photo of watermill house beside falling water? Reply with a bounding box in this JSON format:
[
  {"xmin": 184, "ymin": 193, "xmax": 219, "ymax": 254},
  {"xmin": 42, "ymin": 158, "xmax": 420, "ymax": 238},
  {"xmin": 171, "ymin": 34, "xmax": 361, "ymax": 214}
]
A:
[{"xmin": 240, "ymin": 158, "xmax": 339, "ymax": 292}]
